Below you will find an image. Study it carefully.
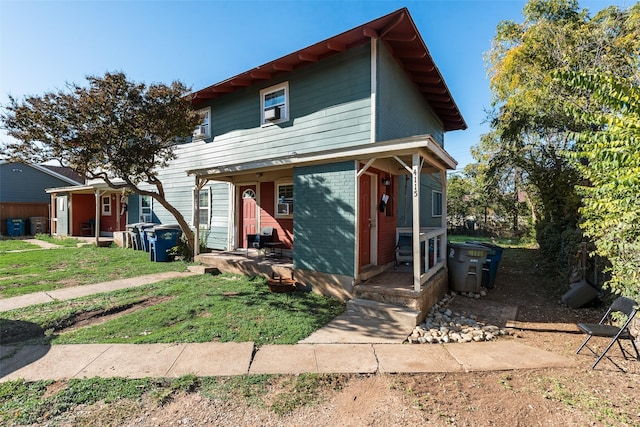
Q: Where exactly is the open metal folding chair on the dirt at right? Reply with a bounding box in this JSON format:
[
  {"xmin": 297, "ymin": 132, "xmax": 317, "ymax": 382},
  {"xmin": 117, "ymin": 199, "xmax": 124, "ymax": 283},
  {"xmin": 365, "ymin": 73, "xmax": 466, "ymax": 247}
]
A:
[{"xmin": 576, "ymin": 297, "xmax": 640, "ymax": 370}]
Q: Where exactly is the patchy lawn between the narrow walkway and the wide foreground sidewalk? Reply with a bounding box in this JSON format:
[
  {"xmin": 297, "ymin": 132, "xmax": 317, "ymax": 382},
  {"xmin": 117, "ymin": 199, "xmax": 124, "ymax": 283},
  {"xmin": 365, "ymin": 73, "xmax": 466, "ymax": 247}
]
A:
[{"xmin": 1, "ymin": 274, "xmax": 344, "ymax": 345}]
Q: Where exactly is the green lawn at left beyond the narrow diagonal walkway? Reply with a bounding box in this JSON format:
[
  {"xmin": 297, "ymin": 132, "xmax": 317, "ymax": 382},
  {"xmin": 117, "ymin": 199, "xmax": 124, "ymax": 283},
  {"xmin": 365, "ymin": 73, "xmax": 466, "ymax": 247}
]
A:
[{"xmin": 0, "ymin": 244, "xmax": 186, "ymax": 298}]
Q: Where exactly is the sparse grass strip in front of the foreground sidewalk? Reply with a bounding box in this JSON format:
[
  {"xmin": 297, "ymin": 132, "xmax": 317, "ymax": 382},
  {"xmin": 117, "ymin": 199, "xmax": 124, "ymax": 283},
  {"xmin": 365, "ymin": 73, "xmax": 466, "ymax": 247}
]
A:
[{"xmin": 0, "ymin": 375, "xmax": 349, "ymax": 425}]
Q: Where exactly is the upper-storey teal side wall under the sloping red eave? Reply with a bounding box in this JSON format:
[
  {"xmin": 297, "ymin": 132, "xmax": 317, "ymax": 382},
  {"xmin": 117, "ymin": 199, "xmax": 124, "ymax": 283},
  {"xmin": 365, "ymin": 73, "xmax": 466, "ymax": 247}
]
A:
[{"xmin": 376, "ymin": 44, "xmax": 444, "ymax": 146}]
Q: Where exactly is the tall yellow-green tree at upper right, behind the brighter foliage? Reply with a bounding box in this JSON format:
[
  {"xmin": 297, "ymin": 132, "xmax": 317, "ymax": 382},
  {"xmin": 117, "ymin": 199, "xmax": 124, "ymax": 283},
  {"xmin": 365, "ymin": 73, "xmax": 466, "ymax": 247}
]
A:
[{"xmin": 477, "ymin": 0, "xmax": 640, "ymax": 267}]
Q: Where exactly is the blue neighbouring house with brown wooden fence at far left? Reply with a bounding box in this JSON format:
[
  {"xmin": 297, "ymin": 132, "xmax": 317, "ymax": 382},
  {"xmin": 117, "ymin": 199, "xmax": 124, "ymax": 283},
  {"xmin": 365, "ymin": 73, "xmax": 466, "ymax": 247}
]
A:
[{"xmin": 0, "ymin": 160, "xmax": 83, "ymax": 236}]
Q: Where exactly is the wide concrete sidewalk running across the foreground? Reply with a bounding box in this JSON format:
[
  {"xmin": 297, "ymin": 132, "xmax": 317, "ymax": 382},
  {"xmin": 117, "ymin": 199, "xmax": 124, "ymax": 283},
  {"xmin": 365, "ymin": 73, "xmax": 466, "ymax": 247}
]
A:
[{"xmin": 0, "ymin": 340, "xmax": 575, "ymax": 381}]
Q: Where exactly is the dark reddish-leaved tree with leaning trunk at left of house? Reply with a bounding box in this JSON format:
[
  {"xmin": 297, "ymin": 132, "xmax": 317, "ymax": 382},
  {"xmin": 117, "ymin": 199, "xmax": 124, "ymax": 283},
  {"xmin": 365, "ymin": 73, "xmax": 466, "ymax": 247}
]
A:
[{"xmin": 0, "ymin": 73, "xmax": 200, "ymax": 253}]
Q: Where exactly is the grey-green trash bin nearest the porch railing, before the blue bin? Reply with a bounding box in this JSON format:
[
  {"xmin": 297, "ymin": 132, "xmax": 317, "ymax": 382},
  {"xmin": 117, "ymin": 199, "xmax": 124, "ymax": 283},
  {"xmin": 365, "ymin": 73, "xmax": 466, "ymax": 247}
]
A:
[{"xmin": 448, "ymin": 243, "xmax": 489, "ymax": 293}]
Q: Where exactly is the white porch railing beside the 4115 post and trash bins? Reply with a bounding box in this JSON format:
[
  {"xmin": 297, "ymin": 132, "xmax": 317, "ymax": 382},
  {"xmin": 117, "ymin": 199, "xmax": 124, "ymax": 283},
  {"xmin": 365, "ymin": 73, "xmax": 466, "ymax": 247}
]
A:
[{"xmin": 396, "ymin": 227, "xmax": 447, "ymax": 292}]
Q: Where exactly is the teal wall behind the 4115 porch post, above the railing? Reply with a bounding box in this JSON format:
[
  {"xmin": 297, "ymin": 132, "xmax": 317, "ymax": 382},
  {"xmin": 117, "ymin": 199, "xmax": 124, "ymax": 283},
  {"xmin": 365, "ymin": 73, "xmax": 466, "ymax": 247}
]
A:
[{"xmin": 397, "ymin": 174, "xmax": 446, "ymax": 227}]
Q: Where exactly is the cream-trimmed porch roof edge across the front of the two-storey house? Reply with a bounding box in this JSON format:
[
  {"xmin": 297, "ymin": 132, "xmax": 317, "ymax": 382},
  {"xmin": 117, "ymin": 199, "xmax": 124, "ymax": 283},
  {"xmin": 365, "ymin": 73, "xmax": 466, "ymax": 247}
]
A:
[{"xmin": 186, "ymin": 135, "xmax": 457, "ymax": 182}]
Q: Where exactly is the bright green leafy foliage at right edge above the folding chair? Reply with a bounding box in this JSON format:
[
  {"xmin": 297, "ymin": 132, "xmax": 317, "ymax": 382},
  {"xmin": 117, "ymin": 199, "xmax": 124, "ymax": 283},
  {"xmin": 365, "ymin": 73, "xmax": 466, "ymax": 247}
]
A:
[{"xmin": 557, "ymin": 72, "xmax": 640, "ymax": 297}]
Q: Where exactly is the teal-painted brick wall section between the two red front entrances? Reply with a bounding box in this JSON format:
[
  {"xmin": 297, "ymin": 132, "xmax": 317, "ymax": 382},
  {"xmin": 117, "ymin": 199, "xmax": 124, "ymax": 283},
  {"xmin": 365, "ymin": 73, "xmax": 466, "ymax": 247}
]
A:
[{"xmin": 293, "ymin": 162, "xmax": 356, "ymax": 276}]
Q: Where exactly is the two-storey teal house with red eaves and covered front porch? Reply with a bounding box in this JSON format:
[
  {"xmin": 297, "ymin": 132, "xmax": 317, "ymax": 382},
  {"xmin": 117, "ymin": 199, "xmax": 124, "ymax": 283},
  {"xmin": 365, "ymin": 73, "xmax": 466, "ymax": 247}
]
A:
[{"xmin": 48, "ymin": 9, "xmax": 466, "ymax": 304}]
